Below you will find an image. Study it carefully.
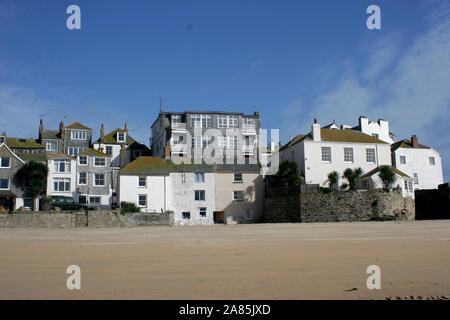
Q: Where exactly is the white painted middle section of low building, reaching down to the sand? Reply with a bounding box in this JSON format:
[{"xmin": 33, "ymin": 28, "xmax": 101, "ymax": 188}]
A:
[{"xmin": 169, "ymin": 172, "xmax": 215, "ymax": 225}]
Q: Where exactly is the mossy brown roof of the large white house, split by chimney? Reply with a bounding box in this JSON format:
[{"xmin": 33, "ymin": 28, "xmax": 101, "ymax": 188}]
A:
[{"xmin": 280, "ymin": 128, "xmax": 388, "ymax": 150}]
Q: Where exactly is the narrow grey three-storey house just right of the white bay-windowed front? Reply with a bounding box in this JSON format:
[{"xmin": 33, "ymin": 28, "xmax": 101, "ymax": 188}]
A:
[{"xmin": 75, "ymin": 148, "xmax": 112, "ymax": 209}]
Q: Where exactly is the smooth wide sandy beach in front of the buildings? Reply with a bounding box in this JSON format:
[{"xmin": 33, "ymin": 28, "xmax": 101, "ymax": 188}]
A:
[{"xmin": 0, "ymin": 221, "xmax": 450, "ymax": 299}]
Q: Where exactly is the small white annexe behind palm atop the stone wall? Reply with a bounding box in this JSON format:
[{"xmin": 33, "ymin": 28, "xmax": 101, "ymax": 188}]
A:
[{"xmin": 360, "ymin": 166, "xmax": 414, "ymax": 198}]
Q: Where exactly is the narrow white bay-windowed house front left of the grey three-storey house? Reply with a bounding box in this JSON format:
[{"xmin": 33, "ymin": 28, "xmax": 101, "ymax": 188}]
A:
[{"xmin": 47, "ymin": 153, "xmax": 77, "ymax": 201}]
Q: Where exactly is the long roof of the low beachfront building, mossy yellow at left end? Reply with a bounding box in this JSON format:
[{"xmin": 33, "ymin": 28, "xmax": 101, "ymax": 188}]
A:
[{"xmin": 120, "ymin": 156, "xmax": 260, "ymax": 175}]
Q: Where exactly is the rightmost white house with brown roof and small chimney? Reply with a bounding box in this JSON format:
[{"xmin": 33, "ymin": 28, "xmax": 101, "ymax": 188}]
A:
[{"xmin": 391, "ymin": 135, "xmax": 444, "ymax": 189}]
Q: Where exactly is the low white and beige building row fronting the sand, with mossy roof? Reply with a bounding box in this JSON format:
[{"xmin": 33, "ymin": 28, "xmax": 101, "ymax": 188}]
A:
[{"xmin": 119, "ymin": 157, "xmax": 263, "ymax": 225}]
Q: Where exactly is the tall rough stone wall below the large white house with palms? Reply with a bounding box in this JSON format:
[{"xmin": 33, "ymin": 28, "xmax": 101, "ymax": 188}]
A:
[{"xmin": 264, "ymin": 190, "xmax": 415, "ymax": 222}]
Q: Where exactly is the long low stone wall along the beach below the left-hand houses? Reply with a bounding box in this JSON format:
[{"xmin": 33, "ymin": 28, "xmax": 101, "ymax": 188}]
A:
[{"xmin": 0, "ymin": 211, "xmax": 173, "ymax": 228}]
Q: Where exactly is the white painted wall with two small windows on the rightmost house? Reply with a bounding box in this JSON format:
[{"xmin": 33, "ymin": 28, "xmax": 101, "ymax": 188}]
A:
[{"xmin": 393, "ymin": 148, "xmax": 444, "ymax": 189}]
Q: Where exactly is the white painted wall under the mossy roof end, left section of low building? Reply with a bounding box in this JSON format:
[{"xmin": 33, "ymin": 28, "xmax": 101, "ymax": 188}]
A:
[{"xmin": 118, "ymin": 175, "xmax": 170, "ymax": 212}]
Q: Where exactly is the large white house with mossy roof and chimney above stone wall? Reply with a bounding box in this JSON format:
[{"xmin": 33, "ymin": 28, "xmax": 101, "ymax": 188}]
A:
[{"xmin": 280, "ymin": 120, "xmax": 391, "ymax": 187}]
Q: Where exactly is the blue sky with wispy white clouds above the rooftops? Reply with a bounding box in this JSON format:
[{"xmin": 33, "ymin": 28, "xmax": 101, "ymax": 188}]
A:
[{"xmin": 0, "ymin": 0, "xmax": 450, "ymax": 181}]
